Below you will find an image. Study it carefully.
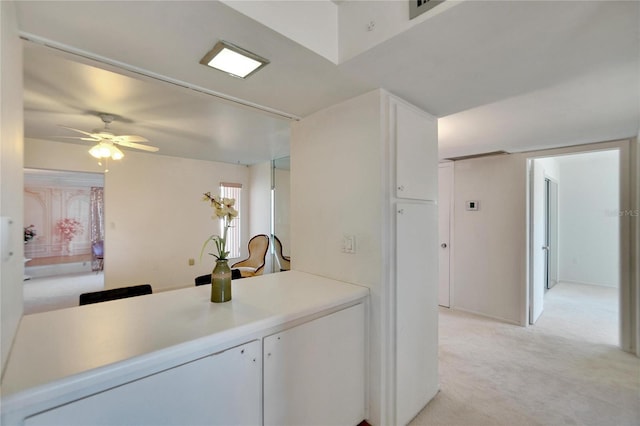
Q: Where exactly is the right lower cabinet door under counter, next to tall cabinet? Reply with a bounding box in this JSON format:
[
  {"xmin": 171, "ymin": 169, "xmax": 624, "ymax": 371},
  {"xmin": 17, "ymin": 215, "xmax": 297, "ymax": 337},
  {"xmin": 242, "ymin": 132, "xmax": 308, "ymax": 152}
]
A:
[{"xmin": 263, "ymin": 304, "xmax": 365, "ymax": 426}]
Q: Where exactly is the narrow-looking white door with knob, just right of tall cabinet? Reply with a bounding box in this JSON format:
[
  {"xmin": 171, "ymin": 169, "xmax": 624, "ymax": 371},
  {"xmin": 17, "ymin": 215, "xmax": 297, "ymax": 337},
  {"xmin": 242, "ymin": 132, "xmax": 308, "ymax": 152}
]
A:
[{"xmin": 438, "ymin": 163, "xmax": 453, "ymax": 308}]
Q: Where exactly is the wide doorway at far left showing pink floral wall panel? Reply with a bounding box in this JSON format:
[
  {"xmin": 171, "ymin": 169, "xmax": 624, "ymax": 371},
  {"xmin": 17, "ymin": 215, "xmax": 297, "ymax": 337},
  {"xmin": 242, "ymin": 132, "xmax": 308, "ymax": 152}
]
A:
[{"xmin": 23, "ymin": 169, "xmax": 104, "ymax": 314}]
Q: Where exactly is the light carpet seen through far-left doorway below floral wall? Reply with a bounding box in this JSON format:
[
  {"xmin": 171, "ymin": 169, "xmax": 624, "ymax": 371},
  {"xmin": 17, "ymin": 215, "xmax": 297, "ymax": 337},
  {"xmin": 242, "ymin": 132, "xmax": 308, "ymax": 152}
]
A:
[{"xmin": 23, "ymin": 272, "xmax": 104, "ymax": 315}]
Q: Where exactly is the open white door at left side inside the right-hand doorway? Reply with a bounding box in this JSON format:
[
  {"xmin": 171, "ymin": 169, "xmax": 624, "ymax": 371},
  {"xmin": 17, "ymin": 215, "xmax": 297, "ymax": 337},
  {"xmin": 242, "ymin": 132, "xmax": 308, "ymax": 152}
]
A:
[{"xmin": 529, "ymin": 160, "xmax": 546, "ymax": 324}]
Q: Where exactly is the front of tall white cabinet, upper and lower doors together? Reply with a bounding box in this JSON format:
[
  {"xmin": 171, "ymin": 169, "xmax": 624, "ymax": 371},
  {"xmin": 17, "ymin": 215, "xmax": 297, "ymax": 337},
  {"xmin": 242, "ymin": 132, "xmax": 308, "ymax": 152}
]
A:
[{"xmin": 388, "ymin": 97, "xmax": 438, "ymax": 425}]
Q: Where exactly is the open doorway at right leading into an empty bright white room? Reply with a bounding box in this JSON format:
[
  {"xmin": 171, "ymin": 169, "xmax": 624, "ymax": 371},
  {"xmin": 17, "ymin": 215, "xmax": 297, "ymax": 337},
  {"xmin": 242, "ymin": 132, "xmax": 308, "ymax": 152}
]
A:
[{"xmin": 529, "ymin": 149, "xmax": 621, "ymax": 343}]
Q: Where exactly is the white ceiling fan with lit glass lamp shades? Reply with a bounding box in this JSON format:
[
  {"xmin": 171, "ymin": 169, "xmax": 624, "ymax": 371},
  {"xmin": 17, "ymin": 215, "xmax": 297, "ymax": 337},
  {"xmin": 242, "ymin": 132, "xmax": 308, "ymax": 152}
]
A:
[{"xmin": 60, "ymin": 113, "xmax": 159, "ymax": 156}]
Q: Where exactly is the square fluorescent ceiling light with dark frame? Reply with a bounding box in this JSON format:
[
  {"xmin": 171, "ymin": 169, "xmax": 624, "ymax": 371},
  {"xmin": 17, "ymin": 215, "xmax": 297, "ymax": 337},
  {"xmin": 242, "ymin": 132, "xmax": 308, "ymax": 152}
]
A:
[{"xmin": 200, "ymin": 41, "xmax": 269, "ymax": 78}]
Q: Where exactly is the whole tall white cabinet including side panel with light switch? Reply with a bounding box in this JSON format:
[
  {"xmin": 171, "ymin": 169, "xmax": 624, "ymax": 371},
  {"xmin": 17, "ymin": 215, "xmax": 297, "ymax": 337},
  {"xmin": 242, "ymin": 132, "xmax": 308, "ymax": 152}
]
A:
[{"xmin": 291, "ymin": 90, "xmax": 438, "ymax": 426}]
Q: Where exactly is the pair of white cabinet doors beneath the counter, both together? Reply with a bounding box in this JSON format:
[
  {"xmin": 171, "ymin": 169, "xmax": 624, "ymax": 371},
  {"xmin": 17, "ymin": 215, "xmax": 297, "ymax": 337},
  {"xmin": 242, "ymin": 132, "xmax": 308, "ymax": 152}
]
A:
[{"xmin": 18, "ymin": 303, "xmax": 366, "ymax": 426}]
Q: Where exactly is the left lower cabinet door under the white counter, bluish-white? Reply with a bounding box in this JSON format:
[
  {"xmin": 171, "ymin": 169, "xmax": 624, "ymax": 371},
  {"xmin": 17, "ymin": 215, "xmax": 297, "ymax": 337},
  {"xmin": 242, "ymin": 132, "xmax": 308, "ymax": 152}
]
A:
[{"xmin": 24, "ymin": 340, "xmax": 262, "ymax": 426}]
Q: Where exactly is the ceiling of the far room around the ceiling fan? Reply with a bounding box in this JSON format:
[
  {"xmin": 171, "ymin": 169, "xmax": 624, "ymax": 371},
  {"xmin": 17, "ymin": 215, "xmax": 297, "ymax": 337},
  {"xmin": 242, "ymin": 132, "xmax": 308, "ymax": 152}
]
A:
[{"xmin": 24, "ymin": 43, "xmax": 289, "ymax": 164}]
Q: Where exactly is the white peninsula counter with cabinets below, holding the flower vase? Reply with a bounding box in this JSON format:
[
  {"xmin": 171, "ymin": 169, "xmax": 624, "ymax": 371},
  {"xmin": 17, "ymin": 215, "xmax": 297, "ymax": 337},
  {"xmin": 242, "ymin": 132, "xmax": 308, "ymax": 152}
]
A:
[{"xmin": 2, "ymin": 271, "xmax": 369, "ymax": 425}]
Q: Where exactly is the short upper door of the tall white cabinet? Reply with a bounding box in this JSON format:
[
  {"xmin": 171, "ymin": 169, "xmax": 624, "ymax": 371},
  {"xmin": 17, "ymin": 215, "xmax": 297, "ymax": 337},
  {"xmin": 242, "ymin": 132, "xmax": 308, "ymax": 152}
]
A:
[{"xmin": 391, "ymin": 101, "xmax": 438, "ymax": 200}]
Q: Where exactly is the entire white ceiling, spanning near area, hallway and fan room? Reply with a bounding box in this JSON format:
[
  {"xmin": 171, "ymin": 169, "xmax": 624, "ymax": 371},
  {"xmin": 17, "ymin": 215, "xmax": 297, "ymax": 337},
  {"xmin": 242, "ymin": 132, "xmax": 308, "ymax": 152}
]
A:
[{"xmin": 17, "ymin": 1, "xmax": 640, "ymax": 164}]
